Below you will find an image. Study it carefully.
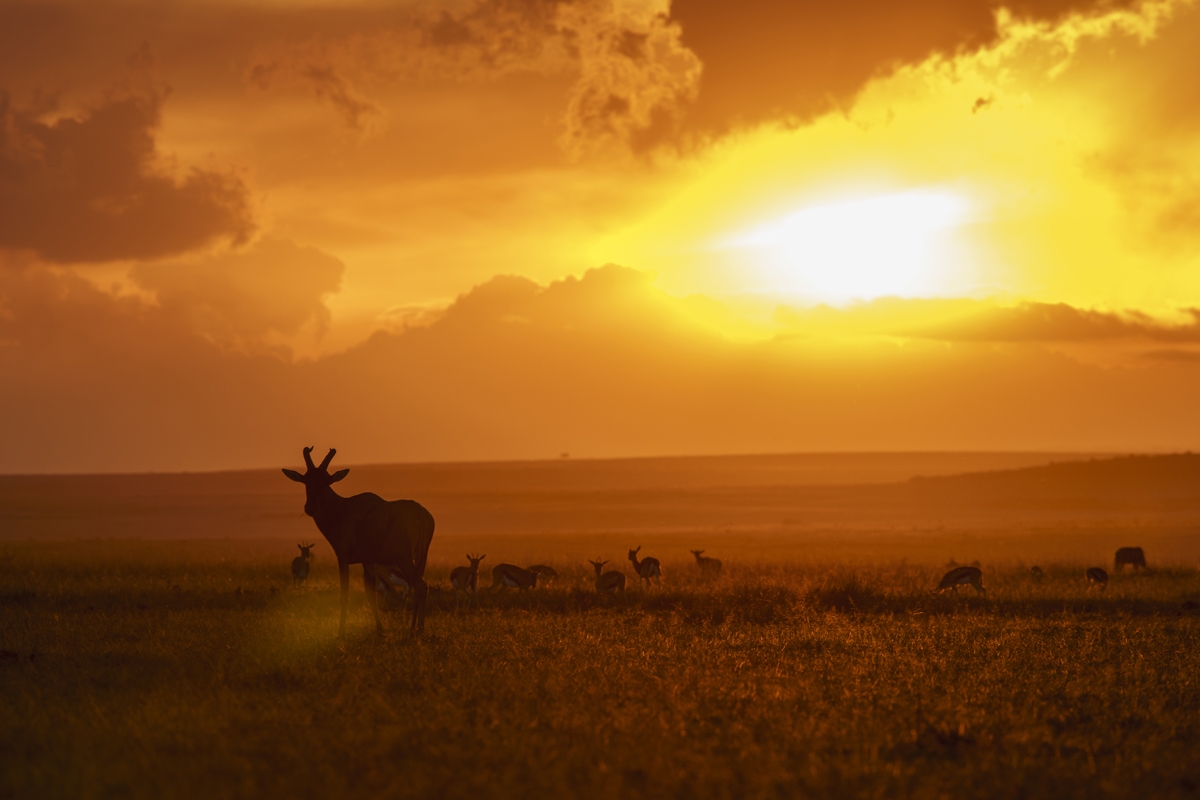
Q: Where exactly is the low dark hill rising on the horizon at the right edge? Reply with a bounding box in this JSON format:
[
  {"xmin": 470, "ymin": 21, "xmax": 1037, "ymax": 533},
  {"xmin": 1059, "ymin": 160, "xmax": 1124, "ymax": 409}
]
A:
[{"xmin": 908, "ymin": 452, "xmax": 1200, "ymax": 501}]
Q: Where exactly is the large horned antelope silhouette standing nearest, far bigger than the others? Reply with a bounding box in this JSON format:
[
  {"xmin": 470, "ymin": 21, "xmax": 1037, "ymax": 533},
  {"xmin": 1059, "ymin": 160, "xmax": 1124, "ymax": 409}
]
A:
[{"xmin": 283, "ymin": 447, "xmax": 433, "ymax": 636}]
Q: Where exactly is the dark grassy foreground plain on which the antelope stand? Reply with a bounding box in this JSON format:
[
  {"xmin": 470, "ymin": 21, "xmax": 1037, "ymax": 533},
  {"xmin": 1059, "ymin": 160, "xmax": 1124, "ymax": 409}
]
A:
[{"xmin": 0, "ymin": 537, "xmax": 1200, "ymax": 798}]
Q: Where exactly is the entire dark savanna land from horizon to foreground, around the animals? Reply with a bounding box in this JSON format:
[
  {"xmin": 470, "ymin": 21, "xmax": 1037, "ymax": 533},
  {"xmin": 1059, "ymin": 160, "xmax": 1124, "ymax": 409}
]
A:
[{"xmin": 7, "ymin": 455, "xmax": 1200, "ymax": 798}]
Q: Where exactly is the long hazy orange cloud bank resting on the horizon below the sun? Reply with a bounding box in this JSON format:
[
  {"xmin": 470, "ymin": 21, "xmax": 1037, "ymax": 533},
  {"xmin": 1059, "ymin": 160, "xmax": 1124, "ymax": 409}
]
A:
[{"xmin": 0, "ymin": 258, "xmax": 1200, "ymax": 471}]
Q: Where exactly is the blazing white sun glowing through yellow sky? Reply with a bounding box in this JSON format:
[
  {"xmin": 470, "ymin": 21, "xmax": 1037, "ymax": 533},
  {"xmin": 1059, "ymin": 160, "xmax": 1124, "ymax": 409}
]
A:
[{"xmin": 718, "ymin": 190, "xmax": 970, "ymax": 302}]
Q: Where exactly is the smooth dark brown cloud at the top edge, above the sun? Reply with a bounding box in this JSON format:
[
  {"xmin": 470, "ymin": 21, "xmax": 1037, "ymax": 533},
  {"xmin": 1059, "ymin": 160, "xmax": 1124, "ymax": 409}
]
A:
[{"xmin": 671, "ymin": 0, "xmax": 1133, "ymax": 132}]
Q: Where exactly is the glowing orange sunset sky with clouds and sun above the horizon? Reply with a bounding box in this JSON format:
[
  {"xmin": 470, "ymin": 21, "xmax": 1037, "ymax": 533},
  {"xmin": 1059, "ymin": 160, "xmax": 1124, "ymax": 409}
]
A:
[{"xmin": 0, "ymin": 0, "xmax": 1200, "ymax": 473}]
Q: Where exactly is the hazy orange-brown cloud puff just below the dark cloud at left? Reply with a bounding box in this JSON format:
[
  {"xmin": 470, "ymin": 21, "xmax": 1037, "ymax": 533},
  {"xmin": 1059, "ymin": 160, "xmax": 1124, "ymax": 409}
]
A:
[{"xmin": 131, "ymin": 239, "xmax": 346, "ymax": 345}]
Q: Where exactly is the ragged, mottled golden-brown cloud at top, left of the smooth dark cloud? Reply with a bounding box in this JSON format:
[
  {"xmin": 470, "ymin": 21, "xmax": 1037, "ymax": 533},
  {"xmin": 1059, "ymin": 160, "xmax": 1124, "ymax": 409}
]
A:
[{"xmin": 247, "ymin": 0, "xmax": 701, "ymax": 156}]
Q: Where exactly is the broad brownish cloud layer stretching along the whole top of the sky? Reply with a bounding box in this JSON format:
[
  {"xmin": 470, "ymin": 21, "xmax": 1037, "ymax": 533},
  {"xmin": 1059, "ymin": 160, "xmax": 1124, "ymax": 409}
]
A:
[{"xmin": 0, "ymin": 0, "xmax": 1142, "ymax": 163}]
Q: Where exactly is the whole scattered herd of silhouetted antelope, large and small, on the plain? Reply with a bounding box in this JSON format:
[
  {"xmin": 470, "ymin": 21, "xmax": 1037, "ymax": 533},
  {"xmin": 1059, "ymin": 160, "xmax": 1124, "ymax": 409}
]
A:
[{"xmin": 283, "ymin": 447, "xmax": 1161, "ymax": 636}]
